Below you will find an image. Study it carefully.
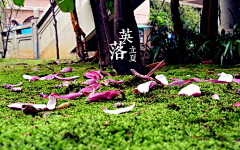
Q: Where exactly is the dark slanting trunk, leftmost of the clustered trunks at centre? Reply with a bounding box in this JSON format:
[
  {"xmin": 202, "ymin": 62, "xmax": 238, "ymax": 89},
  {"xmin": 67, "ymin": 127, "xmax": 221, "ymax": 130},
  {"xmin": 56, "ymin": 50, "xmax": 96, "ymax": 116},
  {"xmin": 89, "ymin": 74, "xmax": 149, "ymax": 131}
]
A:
[{"xmin": 90, "ymin": 0, "xmax": 111, "ymax": 69}]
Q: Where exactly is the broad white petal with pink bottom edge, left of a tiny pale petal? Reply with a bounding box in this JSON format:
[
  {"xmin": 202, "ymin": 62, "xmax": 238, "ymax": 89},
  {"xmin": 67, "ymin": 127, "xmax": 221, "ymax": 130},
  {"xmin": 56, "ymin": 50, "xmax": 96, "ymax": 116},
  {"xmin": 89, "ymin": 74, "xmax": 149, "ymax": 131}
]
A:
[{"xmin": 178, "ymin": 84, "xmax": 201, "ymax": 96}]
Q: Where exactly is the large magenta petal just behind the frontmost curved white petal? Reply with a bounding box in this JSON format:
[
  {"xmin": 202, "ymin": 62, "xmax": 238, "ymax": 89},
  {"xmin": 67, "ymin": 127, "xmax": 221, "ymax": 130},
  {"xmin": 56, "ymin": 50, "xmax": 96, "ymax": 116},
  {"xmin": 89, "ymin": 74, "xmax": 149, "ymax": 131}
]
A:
[{"xmin": 87, "ymin": 90, "xmax": 125, "ymax": 101}]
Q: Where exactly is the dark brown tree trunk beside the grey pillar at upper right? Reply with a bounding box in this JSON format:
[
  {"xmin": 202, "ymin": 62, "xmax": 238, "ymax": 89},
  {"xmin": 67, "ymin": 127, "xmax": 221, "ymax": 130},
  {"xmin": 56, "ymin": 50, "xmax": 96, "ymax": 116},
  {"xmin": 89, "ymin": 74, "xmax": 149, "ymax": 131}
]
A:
[{"xmin": 200, "ymin": 0, "xmax": 218, "ymax": 40}]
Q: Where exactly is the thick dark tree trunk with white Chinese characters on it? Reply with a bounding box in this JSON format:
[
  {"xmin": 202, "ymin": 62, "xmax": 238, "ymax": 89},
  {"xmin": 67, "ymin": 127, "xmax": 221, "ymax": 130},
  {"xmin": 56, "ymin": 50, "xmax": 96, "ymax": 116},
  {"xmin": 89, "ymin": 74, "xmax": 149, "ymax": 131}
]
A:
[{"xmin": 111, "ymin": 0, "xmax": 143, "ymax": 75}]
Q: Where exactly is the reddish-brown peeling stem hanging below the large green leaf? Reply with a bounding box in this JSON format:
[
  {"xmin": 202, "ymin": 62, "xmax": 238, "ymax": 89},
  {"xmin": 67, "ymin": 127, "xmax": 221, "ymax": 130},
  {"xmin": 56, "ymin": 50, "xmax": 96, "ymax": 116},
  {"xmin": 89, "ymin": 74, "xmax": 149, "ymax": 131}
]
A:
[{"xmin": 71, "ymin": 0, "xmax": 86, "ymax": 61}]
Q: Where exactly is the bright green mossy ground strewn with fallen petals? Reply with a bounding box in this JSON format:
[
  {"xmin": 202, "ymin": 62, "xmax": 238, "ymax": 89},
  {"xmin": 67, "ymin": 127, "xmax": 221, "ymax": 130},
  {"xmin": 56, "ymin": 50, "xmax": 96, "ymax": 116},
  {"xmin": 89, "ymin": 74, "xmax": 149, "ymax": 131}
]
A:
[{"xmin": 0, "ymin": 59, "xmax": 240, "ymax": 150}]
